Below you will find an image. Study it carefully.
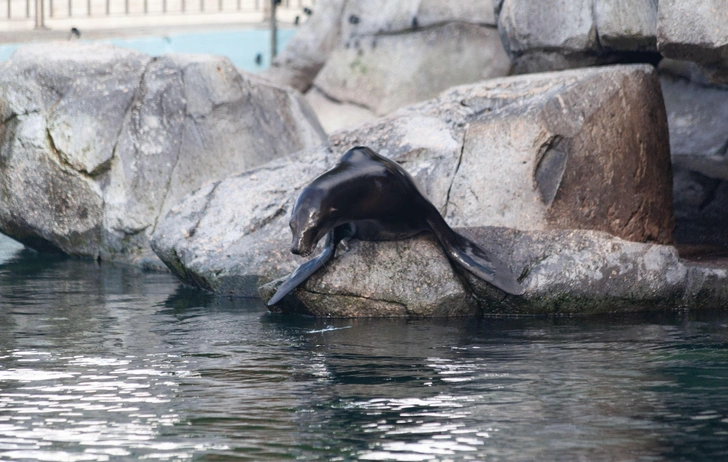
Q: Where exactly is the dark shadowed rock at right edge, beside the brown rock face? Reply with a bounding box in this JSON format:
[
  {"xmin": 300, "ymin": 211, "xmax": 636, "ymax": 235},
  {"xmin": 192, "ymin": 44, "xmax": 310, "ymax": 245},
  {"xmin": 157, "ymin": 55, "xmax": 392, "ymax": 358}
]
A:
[{"xmin": 660, "ymin": 59, "xmax": 728, "ymax": 248}]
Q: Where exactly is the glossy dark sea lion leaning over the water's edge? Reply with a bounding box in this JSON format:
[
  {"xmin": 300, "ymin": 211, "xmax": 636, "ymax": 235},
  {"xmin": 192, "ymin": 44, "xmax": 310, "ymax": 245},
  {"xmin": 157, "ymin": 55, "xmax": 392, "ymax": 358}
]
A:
[{"xmin": 268, "ymin": 146, "xmax": 525, "ymax": 306}]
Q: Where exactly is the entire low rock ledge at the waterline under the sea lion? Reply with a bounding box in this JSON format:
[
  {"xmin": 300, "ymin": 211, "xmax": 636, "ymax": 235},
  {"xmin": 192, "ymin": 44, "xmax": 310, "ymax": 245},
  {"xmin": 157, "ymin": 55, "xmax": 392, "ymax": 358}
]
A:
[{"xmin": 261, "ymin": 228, "xmax": 728, "ymax": 317}]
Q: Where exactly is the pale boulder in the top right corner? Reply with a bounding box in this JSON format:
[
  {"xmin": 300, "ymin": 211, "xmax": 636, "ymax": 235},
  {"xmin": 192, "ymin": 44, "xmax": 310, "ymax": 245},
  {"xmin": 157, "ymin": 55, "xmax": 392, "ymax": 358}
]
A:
[{"xmin": 657, "ymin": 0, "xmax": 728, "ymax": 83}]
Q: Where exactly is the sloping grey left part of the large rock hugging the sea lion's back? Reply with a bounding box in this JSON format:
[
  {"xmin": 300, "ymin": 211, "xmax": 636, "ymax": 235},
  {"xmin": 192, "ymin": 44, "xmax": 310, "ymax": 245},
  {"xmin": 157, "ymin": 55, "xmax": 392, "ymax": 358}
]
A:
[{"xmin": 152, "ymin": 110, "xmax": 465, "ymax": 296}]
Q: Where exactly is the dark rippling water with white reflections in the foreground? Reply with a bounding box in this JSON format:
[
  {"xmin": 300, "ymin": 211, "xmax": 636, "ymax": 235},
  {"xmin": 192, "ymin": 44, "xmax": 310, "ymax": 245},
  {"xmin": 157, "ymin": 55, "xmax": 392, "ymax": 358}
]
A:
[{"xmin": 0, "ymin": 238, "xmax": 728, "ymax": 461}]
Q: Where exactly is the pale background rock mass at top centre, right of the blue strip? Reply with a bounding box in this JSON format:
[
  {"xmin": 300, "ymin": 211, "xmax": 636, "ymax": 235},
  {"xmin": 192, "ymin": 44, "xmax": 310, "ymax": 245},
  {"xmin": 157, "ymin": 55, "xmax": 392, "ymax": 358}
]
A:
[{"xmin": 263, "ymin": 0, "xmax": 511, "ymax": 133}]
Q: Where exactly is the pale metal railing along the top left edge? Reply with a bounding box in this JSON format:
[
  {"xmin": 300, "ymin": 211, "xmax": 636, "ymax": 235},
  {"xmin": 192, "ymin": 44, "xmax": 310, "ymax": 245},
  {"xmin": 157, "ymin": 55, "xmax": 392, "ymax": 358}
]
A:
[{"xmin": 0, "ymin": 0, "xmax": 316, "ymax": 28}]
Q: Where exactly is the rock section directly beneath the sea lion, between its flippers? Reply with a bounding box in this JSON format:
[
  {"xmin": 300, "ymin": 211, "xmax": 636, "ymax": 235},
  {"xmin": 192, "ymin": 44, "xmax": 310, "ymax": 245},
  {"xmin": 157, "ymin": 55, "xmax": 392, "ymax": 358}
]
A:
[{"xmin": 261, "ymin": 236, "xmax": 478, "ymax": 317}]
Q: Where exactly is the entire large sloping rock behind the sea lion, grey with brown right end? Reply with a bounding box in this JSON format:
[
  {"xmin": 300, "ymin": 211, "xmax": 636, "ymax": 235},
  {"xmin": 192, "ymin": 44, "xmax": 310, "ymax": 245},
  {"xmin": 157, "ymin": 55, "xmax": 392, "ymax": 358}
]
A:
[{"xmin": 152, "ymin": 66, "xmax": 673, "ymax": 295}]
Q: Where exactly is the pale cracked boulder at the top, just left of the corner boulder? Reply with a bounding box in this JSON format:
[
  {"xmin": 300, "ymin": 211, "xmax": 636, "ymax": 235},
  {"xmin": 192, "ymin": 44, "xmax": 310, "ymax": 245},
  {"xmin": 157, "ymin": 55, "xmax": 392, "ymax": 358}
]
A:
[{"xmin": 494, "ymin": 0, "xmax": 659, "ymax": 73}]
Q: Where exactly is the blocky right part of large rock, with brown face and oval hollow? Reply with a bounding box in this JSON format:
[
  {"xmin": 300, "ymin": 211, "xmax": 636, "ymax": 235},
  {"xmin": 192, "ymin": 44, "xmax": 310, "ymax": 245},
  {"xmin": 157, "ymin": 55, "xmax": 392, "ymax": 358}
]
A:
[{"xmin": 438, "ymin": 66, "xmax": 673, "ymax": 243}]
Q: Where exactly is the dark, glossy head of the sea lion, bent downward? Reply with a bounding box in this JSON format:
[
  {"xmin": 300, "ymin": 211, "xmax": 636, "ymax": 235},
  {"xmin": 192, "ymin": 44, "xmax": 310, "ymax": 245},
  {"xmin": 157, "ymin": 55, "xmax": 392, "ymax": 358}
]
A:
[{"xmin": 289, "ymin": 187, "xmax": 336, "ymax": 257}]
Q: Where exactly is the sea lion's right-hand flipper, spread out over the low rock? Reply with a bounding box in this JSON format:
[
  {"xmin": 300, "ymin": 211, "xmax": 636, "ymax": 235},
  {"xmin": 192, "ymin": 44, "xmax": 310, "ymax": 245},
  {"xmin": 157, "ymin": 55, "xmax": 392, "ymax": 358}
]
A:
[{"xmin": 441, "ymin": 231, "xmax": 526, "ymax": 295}]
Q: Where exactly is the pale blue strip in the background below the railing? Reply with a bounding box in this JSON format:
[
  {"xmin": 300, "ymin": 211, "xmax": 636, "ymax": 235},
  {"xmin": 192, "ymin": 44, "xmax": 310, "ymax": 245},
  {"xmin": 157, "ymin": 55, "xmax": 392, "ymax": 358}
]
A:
[{"xmin": 0, "ymin": 29, "xmax": 296, "ymax": 72}]
